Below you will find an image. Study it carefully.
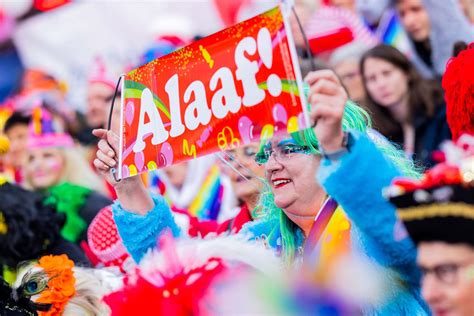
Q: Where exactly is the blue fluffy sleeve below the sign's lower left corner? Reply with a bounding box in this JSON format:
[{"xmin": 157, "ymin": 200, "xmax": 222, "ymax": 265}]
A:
[{"xmin": 112, "ymin": 196, "xmax": 180, "ymax": 262}]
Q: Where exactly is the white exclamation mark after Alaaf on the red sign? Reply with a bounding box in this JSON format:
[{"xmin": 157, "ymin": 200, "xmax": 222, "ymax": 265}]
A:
[{"xmin": 257, "ymin": 27, "xmax": 281, "ymax": 97}]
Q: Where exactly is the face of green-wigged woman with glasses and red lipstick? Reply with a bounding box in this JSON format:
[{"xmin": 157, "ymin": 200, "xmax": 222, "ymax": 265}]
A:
[{"xmin": 265, "ymin": 136, "xmax": 325, "ymax": 218}]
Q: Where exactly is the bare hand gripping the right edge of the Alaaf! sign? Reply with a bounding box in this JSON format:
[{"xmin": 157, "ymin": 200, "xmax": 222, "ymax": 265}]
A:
[{"xmin": 305, "ymin": 70, "xmax": 348, "ymax": 152}]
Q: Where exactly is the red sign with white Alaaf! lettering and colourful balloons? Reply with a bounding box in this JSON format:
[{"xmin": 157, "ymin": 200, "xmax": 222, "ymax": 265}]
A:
[{"xmin": 118, "ymin": 7, "xmax": 309, "ymax": 178}]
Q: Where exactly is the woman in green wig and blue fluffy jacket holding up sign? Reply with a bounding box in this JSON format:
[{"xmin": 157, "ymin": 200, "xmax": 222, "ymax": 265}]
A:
[{"xmin": 94, "ymin": 70, "xmax": 427, "ymax": 315}]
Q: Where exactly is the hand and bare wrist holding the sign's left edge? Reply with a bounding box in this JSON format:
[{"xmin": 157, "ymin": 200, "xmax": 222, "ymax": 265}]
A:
[{"xmin": 92, "ymin": 129, "xmax": 154, "ymax": 214}]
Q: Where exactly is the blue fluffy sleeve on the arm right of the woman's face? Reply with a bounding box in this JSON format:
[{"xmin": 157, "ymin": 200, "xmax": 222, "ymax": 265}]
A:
[{"xmin": 317, "ymin": 131, "xmax": 418, "ymax": 279}]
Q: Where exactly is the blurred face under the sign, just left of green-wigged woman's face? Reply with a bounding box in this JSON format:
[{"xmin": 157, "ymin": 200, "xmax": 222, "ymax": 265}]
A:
[{"xmin": 222, "ymin": 143, "xmax": 265, "ymax": 203}]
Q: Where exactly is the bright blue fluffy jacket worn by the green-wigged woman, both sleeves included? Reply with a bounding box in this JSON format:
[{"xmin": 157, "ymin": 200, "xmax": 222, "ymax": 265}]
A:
[{"xmin": 113, "ymin": 131, "xmax": 429, "ymax": 315}]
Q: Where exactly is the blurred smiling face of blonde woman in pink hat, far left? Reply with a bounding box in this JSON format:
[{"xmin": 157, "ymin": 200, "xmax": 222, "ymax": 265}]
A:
[{"xmin": 25, "ymin": 148, "xmax": 66, "ymax": 189}]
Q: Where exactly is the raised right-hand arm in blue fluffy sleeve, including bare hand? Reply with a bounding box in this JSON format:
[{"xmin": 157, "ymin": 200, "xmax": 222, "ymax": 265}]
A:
[{"xmin": 306, "ymin": 71, "xmax": 416, "ymax": 275}]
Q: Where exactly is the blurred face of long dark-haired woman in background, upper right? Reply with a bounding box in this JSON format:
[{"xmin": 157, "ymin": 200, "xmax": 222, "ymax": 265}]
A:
[{"xmin": 363, "ymin": 57, "xmax": 408, "ymax": 108}]
